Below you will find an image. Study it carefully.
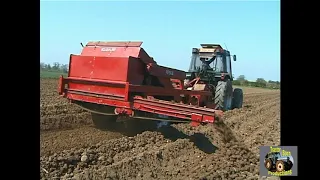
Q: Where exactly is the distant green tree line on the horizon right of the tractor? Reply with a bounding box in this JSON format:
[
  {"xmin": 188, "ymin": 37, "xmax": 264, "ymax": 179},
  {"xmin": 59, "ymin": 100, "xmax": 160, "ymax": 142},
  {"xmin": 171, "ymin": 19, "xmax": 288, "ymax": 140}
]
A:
[{"xmin": 232, "ymin": 75, "xmax": 280, "ymax": 89}]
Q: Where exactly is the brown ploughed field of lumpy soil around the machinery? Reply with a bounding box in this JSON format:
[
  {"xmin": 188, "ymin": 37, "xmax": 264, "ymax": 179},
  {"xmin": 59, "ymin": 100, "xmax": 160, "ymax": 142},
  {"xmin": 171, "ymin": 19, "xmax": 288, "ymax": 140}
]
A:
[{"xmin": 40, "ymin": 79, "xmax": 280, "ymax": 180}]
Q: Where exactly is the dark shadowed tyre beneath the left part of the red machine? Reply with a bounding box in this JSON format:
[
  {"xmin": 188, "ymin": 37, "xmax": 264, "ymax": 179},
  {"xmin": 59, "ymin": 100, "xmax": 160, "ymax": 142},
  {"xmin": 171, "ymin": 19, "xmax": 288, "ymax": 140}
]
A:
[{"xmin": 91, "ymin": 113, "xmax": 117, "ymax": 130}]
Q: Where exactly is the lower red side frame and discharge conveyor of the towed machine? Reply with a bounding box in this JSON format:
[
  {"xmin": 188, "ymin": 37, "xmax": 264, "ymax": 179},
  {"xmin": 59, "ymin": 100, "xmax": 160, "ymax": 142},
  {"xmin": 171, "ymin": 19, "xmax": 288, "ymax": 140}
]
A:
[{"xmin": 58, "ymin": 76, "xmax": 222, "ymax": 125}]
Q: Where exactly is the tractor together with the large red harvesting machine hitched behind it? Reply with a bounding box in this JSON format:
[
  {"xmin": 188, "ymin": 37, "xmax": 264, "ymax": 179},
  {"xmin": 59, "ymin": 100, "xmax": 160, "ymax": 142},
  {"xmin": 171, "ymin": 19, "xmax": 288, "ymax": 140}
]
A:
[{"xmin": 58, "ymin": 41, "xmax": 243, "ymax": 129}]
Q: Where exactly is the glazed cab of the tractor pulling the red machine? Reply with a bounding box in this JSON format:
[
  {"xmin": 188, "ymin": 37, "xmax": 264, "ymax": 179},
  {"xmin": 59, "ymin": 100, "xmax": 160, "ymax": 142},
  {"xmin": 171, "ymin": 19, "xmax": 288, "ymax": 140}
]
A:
[{"xmin": 187, "ymin": 44, "xmax": 236, "ymax": 80}]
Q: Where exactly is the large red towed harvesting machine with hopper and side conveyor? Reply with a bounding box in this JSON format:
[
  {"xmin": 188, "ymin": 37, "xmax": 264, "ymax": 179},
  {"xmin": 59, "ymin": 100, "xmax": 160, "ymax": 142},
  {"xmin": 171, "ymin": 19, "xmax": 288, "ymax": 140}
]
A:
[{"xmin": 58, "ymin": 41, "xmax": 222, "ymax": 125}]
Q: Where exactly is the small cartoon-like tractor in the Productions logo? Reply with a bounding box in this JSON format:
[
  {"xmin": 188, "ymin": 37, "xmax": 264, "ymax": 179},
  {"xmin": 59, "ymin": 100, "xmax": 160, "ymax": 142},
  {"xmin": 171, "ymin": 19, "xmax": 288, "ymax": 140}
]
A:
[{"xmin": 264, "ymin": 152, "xmax": 293, "ymax": 172}]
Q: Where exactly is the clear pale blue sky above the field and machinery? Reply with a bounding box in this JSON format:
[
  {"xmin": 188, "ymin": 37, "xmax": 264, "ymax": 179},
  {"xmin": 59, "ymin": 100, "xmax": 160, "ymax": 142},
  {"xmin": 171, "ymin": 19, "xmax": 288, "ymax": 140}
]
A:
[{"xmin": 40, "ymin": 1, "xmax": 280, "ymax": 80}]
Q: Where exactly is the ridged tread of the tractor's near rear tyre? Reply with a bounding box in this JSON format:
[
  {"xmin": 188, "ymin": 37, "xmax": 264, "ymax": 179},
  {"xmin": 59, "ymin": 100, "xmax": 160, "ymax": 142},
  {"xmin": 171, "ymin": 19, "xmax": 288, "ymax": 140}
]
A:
[{"xmin": 214, "ymin": 80, "xmax": 232, "ymax": 111}]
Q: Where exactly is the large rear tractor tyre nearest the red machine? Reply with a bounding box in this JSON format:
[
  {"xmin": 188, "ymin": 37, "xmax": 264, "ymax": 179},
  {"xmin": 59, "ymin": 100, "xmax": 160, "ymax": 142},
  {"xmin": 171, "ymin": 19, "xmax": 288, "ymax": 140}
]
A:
[{"xmin": 214, "ymin": 79, "xmax": 232, "ymax": 111}]
